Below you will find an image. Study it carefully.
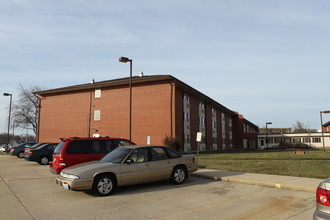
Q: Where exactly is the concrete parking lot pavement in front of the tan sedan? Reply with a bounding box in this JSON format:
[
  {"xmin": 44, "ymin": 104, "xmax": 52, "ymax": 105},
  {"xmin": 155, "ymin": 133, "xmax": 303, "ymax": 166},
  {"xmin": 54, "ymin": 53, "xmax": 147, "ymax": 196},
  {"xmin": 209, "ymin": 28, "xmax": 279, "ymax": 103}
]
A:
[{"xmin": 0, "ymin": 155, "xmax": 315, "ymax": 220}]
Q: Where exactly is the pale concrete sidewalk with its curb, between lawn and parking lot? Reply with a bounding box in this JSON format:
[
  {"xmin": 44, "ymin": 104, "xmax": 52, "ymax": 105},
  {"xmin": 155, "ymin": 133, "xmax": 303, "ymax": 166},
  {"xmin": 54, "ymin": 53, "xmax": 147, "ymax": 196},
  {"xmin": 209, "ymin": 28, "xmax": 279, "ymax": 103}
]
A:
[{"xmin": 190, "ymin": 169, "xmax": 322, "ymax": 192}]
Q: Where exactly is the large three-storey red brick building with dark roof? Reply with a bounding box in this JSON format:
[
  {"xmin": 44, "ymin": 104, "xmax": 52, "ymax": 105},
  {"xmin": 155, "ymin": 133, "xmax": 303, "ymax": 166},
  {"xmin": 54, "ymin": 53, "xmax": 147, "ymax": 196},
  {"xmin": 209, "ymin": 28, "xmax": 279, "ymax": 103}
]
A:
[{"xmin": 36, "ymin": 75, "xmax": 258, "ymax": 152}]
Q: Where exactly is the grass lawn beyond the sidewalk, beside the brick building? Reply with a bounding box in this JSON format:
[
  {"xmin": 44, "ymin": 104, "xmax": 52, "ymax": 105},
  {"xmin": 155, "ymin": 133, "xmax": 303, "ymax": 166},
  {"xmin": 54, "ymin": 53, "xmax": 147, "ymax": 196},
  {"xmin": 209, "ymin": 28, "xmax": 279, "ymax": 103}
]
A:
[{"xmin": 198, "ymin": 150, "xmax": 330, "ymax": 179}]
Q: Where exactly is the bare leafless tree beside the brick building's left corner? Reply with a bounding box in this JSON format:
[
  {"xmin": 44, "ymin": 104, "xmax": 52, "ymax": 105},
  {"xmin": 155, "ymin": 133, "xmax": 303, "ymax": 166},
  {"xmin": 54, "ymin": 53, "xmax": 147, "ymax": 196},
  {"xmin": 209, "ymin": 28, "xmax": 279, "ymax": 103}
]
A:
[{"xmin": 12, "ymin": 84, "xmax": 42, "ymax": 134}]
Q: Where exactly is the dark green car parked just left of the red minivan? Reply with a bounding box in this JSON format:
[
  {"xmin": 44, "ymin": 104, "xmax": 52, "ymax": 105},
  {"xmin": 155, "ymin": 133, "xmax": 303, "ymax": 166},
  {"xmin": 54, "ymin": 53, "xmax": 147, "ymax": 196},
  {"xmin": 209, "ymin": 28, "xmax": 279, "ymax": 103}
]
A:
[{"xmin": 24, "ymin": 143, "xmax": 58, "ymax": 165}]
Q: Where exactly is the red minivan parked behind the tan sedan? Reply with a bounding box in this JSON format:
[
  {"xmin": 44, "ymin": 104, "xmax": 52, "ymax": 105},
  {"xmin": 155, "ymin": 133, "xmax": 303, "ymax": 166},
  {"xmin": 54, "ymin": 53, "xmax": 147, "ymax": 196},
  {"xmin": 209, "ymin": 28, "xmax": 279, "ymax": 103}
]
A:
[{"xmin": 50, "ymin": 137, "xmax": 134, "ymax": 174}]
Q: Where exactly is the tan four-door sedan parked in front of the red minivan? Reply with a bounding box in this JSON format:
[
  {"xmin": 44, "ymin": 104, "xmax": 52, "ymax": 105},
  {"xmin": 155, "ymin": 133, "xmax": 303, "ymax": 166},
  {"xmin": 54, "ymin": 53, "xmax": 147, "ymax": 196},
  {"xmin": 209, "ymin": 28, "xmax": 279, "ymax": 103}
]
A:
[{"xmin": 56, "ymin": 145, "xmax": 198, "ymax": 196}]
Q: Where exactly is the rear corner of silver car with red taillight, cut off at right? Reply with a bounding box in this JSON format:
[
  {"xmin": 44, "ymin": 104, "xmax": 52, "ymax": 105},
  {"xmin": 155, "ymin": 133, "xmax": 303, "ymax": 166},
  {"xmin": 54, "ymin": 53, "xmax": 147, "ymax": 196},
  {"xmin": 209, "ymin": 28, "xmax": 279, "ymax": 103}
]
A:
[{"xmin": 313, "ymin": 178, "xmax": 330, "ymax": 220}]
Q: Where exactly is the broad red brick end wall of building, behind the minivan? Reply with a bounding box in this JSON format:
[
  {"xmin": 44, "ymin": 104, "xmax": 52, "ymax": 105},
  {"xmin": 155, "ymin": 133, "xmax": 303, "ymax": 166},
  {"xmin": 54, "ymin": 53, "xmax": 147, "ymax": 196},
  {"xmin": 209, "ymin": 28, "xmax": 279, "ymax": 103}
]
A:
[{"xmin": 39, "ymin": 82, "xmax": 174, "ymax": 144}]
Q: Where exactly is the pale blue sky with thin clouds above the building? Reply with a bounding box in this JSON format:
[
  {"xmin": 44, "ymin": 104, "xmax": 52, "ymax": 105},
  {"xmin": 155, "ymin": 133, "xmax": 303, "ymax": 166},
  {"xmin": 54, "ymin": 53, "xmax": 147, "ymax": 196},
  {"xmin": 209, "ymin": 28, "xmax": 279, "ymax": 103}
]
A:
[{"xmin": 0, "ymin": 0, "xmax": 330, "ymax": 132}]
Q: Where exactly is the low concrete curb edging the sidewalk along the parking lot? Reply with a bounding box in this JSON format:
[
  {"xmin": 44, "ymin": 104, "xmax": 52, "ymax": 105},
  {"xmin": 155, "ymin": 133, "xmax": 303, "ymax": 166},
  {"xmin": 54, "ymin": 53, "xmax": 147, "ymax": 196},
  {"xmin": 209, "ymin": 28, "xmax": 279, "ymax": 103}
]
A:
[{"xmin": 190, "ymin": 173, "xmax": 316, "ymax": 192}]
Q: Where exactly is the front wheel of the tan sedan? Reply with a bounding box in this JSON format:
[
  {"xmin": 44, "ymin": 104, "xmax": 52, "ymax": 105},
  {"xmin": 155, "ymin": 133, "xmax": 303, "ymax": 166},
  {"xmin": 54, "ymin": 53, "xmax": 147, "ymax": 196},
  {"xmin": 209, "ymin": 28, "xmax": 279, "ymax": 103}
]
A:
[{"xmin": 93, "ymin": 174, "xmax": 116, "ymax": 196}]
